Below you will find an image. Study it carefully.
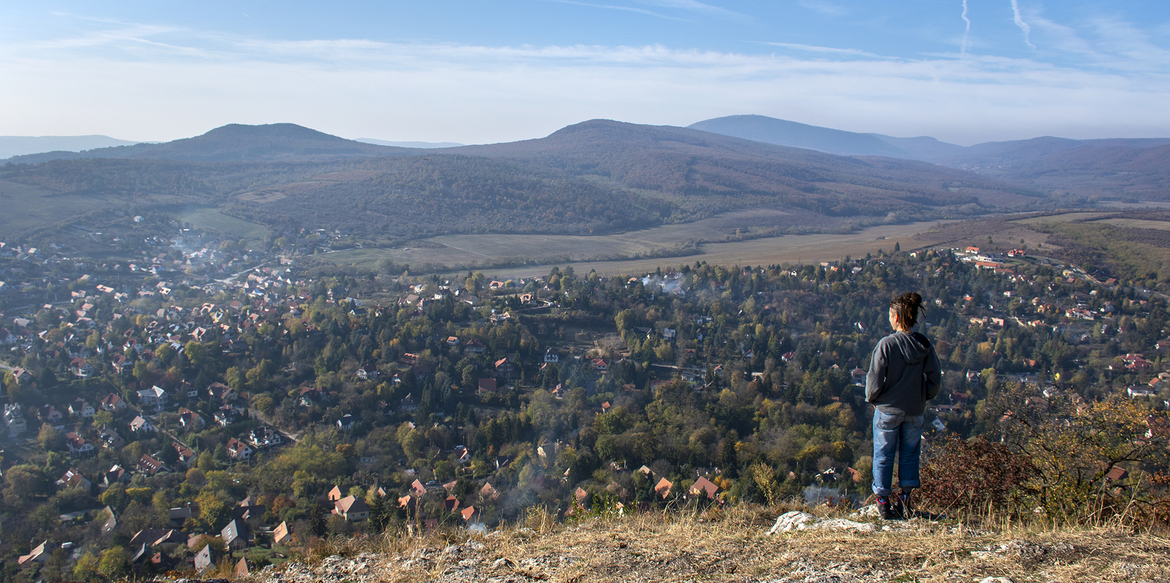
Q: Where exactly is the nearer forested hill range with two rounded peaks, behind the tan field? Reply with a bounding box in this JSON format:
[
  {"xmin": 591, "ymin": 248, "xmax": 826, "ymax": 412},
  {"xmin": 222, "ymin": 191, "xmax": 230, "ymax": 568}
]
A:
[{"xmin": 0, "ymin": 121, "xmax": 1048, "ymax": 241}]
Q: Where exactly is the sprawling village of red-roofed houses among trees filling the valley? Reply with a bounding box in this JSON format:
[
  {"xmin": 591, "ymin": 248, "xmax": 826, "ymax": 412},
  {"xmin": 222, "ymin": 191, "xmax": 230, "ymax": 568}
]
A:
[{"xmin": 0, "ymin": 216, "xmax": 1170, "ymax": 581}]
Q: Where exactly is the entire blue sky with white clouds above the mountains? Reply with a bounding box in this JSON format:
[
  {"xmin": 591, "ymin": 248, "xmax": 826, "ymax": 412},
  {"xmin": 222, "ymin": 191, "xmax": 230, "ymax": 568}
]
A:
[{"xmin": 0, "ymin": 0, "xmax": 1170, "ymax": 145}]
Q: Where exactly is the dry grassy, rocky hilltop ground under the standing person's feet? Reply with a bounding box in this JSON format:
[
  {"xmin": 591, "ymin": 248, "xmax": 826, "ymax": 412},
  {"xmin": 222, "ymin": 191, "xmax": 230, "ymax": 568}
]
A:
[{"xmin": 194, "ymin": 509, "xmax": 1170, "ymax": 583}]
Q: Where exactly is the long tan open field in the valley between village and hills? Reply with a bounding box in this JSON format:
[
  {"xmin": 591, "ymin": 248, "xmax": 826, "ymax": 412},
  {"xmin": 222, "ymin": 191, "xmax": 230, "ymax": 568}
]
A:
[{"xmin": 315, "ymin": 217, "xmax": 938, "ymax": 277}]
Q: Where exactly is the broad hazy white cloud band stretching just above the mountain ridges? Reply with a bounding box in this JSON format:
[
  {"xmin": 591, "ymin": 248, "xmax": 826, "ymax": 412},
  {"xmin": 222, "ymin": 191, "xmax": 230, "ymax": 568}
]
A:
[{"xmin": 0, "ymin": 14, "xmax": 1170, "ymax": 143}]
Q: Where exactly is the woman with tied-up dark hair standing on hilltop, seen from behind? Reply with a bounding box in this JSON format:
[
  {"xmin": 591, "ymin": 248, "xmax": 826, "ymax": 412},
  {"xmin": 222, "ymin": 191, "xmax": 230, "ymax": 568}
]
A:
[{"xmin": 866, "ymin": 292, "xmax": 941, "ymax": 520}]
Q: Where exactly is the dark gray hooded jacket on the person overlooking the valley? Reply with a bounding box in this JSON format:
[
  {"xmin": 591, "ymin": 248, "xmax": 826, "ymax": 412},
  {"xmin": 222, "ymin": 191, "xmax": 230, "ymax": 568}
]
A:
[{"xmin": 866, "ymin": 331, "xmax": 942, "ymax": 416}]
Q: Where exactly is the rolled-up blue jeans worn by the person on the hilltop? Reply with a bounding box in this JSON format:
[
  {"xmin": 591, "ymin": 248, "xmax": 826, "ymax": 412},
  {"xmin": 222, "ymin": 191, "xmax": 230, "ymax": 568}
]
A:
[{"xmin": 873, "ymin": 410, "xmax": 925, "ymax": 496}]
